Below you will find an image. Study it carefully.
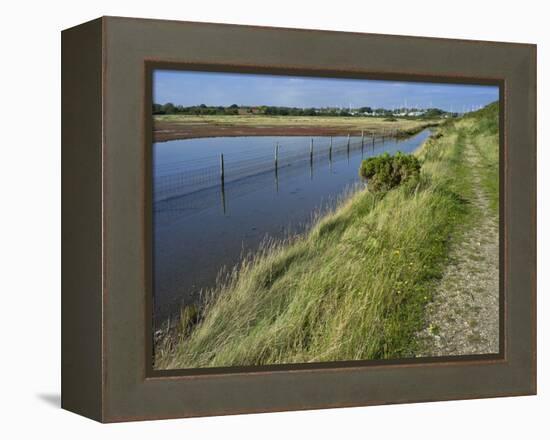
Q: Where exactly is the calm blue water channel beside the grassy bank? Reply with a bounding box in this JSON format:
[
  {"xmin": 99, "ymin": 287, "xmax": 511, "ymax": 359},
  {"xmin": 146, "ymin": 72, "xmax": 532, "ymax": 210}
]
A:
[{"xmin": 153, "ymin": 130, "xmax": 430, "ymax": 326}]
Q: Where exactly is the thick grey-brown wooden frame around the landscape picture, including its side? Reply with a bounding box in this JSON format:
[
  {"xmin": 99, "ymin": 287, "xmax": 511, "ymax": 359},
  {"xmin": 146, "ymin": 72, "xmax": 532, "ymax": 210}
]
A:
[{"xmin": 62, "ymin": 17, "xmax": 536, "ymax": 422}]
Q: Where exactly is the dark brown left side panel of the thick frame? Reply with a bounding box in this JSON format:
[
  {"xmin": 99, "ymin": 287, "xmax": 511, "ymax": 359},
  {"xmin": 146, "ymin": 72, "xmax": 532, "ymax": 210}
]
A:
[{"xmin": 61, "ymin": 19, "xmax": 102, "ymax": 420}]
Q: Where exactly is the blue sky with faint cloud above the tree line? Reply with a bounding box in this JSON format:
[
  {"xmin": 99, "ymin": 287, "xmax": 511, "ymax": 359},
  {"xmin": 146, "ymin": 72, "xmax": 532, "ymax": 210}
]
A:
[{"xmin": 153, "ymin": 69, "xmax": 498, "ymax": 112}]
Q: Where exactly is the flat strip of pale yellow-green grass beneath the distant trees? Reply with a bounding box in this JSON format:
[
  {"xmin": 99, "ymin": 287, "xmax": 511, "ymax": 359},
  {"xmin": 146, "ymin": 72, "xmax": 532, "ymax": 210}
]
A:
[{"xmin": 154, "ymin": 115, "xmax": 441, "ymax": 131}]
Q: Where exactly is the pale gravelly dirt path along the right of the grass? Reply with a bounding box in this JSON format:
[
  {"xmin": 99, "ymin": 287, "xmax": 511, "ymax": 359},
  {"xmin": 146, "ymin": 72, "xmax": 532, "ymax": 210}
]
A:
[{"xmin": 417, "ymin": 132, "xmax": 499, "ymax": 356}]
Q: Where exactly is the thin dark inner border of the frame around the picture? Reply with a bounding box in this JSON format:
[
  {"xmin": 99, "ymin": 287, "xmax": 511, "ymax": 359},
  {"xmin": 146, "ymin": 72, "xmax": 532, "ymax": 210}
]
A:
[{"xmin": 142, "ymin": 58, "xmax": 508, "ymax": 381}]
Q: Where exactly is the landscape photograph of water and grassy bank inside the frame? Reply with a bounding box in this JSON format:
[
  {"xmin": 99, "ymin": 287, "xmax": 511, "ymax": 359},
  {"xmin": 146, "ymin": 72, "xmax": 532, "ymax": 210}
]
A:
[{"xmin": 150, "ymin": 68, "xmax": 500, "ymax": 370}]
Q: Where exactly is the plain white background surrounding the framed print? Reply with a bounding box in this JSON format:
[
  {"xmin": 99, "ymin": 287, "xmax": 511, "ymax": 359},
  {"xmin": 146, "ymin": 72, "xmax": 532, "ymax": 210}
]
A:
[{"xmin": 0, "ymin": 0, "xmax": 550, "ymax": 440}]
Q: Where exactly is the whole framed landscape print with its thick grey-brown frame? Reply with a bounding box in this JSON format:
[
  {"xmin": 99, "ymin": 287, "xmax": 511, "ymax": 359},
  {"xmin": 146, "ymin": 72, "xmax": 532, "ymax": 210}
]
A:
[{"xmin": 62, "ymin": 17, "xmax": 536, "ymax": 422}]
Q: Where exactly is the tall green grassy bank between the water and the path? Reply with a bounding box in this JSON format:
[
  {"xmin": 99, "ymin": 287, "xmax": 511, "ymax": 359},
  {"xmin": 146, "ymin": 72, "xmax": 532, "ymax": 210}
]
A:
[{"xmin": 155, "ymin": 104, "xmax": 498, "ymax": 369}]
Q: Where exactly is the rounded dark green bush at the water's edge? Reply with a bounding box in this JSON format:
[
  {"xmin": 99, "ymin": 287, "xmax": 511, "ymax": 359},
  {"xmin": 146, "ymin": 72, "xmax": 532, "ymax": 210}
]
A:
[{"xmin": 359, "ymin": 152, "xmax": 421, "ymax": 192}]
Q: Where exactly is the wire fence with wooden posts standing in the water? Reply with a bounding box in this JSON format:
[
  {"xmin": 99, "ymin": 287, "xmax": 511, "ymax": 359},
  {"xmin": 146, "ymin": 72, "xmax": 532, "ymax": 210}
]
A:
[{"xmin": 153, "ymin": 135, "xmax": 394, "ymax": 203}]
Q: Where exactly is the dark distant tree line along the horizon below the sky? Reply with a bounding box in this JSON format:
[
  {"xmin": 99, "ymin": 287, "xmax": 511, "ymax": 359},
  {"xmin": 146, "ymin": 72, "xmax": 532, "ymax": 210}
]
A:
[{"xmin": 153, "ymin": 102, "xmax": 447, "ymax": 118}]
